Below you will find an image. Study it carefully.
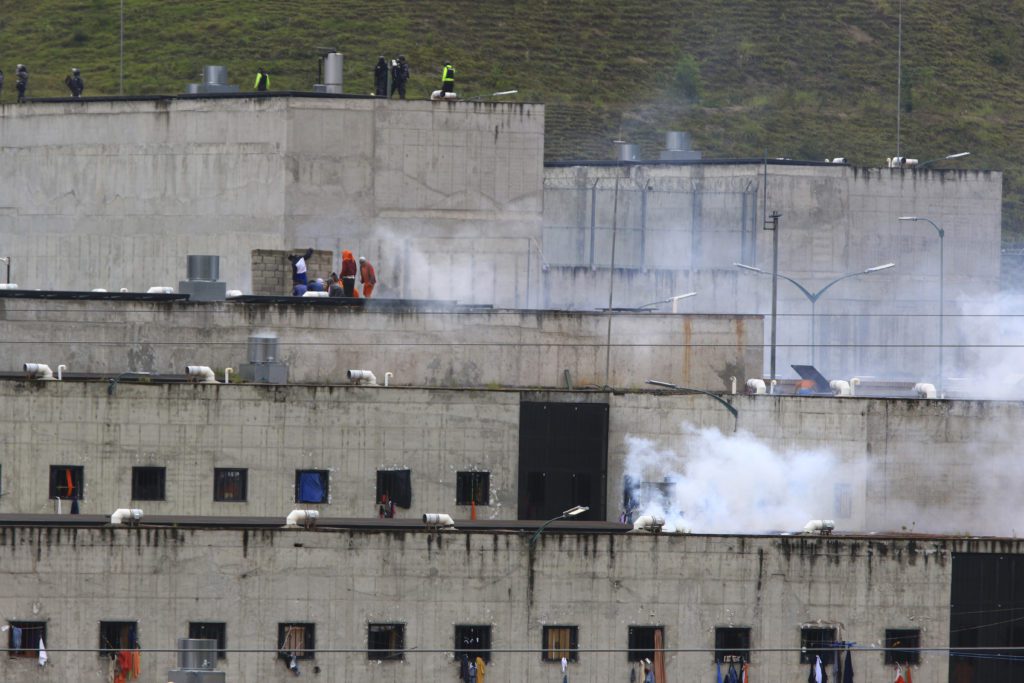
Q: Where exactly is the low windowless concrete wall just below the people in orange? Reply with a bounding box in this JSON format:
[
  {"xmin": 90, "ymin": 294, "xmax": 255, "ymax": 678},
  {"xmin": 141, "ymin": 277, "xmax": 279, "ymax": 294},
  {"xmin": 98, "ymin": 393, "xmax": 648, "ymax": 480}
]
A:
[{"xmin": 0, "ymin": 297, "xmax": 762, "ymax": 391}]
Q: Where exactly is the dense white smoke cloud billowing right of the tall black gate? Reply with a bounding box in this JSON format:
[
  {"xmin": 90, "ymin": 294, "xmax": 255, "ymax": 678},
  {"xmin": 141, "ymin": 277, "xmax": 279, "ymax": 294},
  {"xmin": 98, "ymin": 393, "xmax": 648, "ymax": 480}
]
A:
[{"xmin": 625, "ymin": 424, "xmax": 864, "ymax": 533}]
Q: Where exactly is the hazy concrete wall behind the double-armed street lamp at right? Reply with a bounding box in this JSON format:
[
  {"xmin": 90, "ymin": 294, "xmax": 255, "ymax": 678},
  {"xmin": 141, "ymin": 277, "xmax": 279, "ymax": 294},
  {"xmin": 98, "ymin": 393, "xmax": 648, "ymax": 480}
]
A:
[{"xmin": 543, "ymin": 163, "xmax": 1002, "ymax": 383}]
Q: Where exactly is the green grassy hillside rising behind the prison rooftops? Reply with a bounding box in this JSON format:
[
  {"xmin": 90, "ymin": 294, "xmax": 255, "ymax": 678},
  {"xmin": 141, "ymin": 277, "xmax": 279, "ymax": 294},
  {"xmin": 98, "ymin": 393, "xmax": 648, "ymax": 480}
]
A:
[{"xmin": 6, "ymin": 0, "xmax": 1024, "ymax": 239}]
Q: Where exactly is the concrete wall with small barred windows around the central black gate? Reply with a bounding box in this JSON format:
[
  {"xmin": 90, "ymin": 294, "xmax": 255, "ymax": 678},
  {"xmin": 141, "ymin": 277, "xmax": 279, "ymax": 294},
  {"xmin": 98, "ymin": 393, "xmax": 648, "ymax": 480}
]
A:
[{"xmin": 0, "ymin": 381, "xmax": 1024, "ymax": 536}]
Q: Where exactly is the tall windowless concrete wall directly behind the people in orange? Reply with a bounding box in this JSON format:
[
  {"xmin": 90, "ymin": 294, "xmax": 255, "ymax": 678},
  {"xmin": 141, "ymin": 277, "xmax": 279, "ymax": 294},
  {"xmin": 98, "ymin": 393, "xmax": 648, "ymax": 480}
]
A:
[{"xmin": 0, "ymin": 96, "xmax": 544, "ymax": 305}]
